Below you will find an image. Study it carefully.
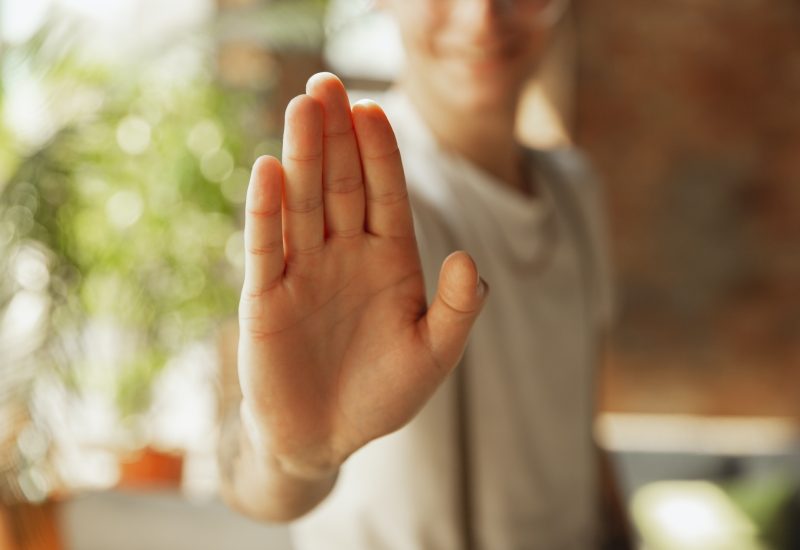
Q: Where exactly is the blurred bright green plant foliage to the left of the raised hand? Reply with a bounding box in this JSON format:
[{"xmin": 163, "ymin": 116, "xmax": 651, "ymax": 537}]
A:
[{"xmin": 0, "ymin": 21, "xmax": 264, "ymax": 496}]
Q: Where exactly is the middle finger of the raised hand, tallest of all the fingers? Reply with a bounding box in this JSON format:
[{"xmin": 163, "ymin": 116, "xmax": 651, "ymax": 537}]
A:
[{"xmin": 306, "ymin": 73, "xmax": 365, "ymax": 237}]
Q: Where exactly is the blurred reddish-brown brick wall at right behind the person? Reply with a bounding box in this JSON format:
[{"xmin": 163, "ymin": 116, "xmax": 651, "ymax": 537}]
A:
[{"xmin": 575, "ymin": 0, "xmax": 800, "ymax": 418}]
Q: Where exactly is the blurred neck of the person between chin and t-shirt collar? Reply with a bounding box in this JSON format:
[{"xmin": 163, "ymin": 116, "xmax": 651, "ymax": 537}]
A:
[{"xmin": 403, "ymin": 74, "xmax": 530, "ymax": 192}]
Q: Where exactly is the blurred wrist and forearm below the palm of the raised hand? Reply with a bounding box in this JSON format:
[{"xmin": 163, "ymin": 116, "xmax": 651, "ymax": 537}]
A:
[{"xmin": 218, "ymin": 406, "xmax": 336, "ymax": 522}]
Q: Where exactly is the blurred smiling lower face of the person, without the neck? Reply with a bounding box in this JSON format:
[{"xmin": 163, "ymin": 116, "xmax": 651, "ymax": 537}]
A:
[{"xmin": 383, "ymin": 0, "xmax": 566, "ymax": 110}]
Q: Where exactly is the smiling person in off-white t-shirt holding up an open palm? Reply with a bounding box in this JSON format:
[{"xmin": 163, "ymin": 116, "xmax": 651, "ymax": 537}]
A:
[{"xmin": 220, "ymin": 0, "xmax": 627, "ymax": 550}]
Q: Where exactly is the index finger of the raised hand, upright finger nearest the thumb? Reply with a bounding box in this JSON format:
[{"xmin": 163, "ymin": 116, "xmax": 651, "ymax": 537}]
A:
[{"xmin": 353, "ymin": 101, "xmax": 414, "ymax": 237}]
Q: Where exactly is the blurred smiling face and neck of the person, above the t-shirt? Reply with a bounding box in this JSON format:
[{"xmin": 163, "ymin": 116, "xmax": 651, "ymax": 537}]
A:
[{"xmin": 382, "ymin": 0, "xmax": 561, "ymax": 192}]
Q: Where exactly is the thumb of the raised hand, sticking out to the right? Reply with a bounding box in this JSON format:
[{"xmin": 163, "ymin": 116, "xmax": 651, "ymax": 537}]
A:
[{"xmin": 420, "ymin": 252, "xmax": 489, "ymax": 371}]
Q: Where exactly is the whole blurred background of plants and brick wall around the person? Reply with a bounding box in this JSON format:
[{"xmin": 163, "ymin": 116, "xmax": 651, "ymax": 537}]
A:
[{"xmin": 0, "ymin": 0, "xmax": 800, "ymax": 550}]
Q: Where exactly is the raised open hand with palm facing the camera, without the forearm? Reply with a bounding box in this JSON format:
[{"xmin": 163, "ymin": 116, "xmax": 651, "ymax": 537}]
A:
[{"xmin": 239, "ymin": 73, "xmax": 486, "ymax": 479}]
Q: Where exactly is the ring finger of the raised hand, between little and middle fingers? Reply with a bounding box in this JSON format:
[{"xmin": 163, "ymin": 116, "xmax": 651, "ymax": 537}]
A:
[{"xmin": 283, "ymin": 95, "xmax": 325, "ymax": 263}]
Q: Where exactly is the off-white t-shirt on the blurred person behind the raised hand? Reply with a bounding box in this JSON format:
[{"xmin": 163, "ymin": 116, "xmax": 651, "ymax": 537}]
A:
[{"xmin": 291, "ymin": 93, "xmax": 612, "ymax": 550}]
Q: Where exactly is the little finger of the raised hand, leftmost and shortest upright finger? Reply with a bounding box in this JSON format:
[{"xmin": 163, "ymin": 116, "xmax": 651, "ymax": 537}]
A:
[{"xmin": 244, "ymin": 157, "xmax": 284, "ymax": 296}]
